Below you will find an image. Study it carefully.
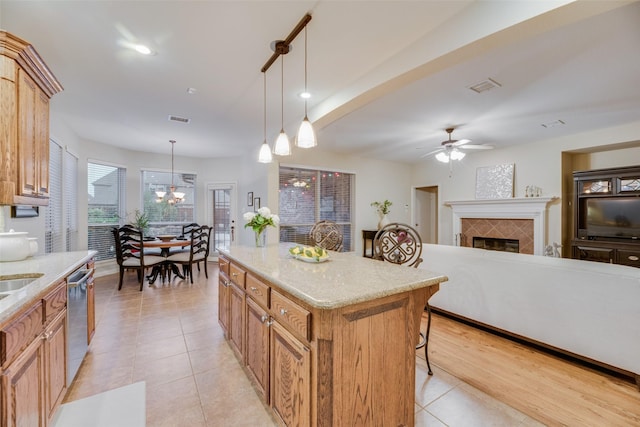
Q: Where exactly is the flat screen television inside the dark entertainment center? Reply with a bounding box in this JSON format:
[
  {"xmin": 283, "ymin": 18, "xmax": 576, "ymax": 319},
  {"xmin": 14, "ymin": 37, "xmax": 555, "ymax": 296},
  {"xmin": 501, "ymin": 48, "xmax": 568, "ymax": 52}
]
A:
[{"xmin": 587, "ymin": 197, "xmax": 640, "ymax": 239}]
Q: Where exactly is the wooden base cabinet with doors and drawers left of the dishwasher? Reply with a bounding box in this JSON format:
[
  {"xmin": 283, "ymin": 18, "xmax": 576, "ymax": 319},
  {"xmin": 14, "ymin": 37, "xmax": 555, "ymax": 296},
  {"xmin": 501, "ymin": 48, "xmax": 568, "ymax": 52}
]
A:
[{"xmin": 0, "ymin": 281, "xmax": 67, "ymax": 426}]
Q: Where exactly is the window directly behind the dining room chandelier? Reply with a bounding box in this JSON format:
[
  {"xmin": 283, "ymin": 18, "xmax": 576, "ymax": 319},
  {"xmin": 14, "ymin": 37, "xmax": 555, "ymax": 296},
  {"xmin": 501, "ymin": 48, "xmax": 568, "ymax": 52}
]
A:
[{"xmin": 141, "ymin": 170, "xmax": 196, "ymax": 235}]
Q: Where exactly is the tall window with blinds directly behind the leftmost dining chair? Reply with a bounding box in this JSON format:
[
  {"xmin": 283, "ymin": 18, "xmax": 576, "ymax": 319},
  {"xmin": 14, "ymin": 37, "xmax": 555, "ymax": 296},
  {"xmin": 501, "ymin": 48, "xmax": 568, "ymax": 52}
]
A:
[{"xmin": 87, "ymin": 162, "xmax": 126, "ymax": 261}]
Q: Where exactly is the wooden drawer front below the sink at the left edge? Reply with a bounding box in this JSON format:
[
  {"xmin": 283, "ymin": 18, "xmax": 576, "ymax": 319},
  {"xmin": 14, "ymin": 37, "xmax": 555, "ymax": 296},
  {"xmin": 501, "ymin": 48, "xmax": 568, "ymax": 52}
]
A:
[{"xmin": 0, "ymin": 302, "xmax": 42, "ymax": 365}]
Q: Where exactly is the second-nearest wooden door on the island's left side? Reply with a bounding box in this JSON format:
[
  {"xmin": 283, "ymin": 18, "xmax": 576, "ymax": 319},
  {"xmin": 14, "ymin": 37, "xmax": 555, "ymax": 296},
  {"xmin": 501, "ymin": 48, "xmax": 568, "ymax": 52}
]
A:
[{"xmin": 245, "ymin": 298, "xmax": 269, "ymax": 403}]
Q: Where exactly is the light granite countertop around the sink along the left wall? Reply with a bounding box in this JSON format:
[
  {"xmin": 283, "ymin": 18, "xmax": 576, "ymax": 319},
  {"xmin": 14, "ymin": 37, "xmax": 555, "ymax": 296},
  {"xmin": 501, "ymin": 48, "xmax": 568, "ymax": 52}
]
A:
[{"xmin": 0, "ymin": 251, "xmax": 97, "ymax": 324}]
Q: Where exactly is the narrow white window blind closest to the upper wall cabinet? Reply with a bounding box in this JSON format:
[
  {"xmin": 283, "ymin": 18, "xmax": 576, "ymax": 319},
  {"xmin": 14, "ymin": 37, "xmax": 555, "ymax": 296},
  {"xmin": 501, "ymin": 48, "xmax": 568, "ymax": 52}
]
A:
[{"xmin": 44, "ymin": 140, "xmax": 64, "ymax": 253}]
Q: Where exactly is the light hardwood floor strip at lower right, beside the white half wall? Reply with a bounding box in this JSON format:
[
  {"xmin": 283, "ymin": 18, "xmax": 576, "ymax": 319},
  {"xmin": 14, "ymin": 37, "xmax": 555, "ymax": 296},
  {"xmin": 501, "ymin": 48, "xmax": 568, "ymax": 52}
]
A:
[{"xmin": 418, "ymin": 314, "xmax": 640, "ymax": 427}]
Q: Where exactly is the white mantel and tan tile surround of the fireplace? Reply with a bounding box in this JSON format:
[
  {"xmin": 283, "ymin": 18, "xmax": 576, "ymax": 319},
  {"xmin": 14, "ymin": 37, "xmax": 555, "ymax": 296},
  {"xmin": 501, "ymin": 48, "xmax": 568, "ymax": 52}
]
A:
[{"xmin": 445, "ymin": 197, "xmax": 557, "ymax": 255}]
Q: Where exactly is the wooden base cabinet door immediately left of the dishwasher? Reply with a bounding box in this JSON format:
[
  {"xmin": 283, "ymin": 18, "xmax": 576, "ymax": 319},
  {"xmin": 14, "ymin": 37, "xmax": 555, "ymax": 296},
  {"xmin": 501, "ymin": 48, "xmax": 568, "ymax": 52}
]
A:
[{"xmin": 44, "ymin": 309, "xmax": 67, "ymax": 419}]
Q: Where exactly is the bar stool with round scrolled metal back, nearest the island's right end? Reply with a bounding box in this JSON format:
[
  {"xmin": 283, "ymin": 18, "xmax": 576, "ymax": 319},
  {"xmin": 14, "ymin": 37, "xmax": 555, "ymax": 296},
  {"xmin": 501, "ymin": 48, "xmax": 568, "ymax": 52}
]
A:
[{"xmin": 373, "ymin": 222, "xmax": 433, "ymax": 375}]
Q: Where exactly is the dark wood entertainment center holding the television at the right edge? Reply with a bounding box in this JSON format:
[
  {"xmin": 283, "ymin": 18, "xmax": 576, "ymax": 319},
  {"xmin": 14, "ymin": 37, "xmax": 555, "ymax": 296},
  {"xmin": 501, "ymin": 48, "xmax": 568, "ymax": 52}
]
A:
[{"xmin": 571, "ymin": 166, "xmax": 640, "ymax": 267}]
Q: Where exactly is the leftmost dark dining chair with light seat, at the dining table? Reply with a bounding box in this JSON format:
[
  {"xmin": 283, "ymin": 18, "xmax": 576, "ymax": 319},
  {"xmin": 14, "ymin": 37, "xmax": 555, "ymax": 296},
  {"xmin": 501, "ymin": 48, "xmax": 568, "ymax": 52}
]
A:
[{"xmin": 112, "ymin": 225, "xmax": 166, "ymax": 291}]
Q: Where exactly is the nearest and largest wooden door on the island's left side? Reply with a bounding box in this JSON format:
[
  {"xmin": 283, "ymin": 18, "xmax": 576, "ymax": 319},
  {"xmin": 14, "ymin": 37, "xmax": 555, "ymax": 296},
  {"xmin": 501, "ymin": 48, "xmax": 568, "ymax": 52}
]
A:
[{"xmin": 270, "ymin": 322, "xmax": 311, "ymax": 426}]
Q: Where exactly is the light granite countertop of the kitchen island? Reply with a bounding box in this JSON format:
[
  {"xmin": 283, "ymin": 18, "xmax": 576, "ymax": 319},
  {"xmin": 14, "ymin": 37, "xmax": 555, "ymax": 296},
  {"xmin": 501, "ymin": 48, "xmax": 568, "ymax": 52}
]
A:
[{"xmin": 218, "ymin": 243, "xmax": 448, "ymax": 309}]
